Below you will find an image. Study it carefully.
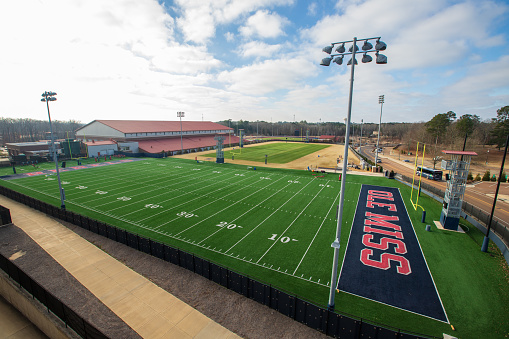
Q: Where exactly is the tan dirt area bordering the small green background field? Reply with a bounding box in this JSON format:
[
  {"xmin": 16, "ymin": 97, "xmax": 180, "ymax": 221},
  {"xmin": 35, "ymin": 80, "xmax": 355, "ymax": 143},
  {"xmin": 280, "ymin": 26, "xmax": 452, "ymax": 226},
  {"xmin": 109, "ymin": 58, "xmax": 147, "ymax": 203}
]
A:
[{"xmin": 175, "ymin": 141, "xmax": 360, "ymax": 170}]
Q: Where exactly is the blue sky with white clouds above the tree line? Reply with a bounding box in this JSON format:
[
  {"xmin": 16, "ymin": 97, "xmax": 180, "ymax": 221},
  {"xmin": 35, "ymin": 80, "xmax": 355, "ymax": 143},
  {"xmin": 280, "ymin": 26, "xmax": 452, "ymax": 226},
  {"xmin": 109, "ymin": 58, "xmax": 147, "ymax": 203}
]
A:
[{"xmin": 0, "ymin": 0, "xmax": 509, "ymax": 123}]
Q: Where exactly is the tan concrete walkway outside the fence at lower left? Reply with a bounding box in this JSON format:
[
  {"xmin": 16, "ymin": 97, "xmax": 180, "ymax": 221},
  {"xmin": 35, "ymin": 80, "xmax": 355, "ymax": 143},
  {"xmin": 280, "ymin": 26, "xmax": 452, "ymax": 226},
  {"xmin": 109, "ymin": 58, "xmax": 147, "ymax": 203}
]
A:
[{"xmin": 0, "ymin": 196, "xmax": 239, "ymax": 338}]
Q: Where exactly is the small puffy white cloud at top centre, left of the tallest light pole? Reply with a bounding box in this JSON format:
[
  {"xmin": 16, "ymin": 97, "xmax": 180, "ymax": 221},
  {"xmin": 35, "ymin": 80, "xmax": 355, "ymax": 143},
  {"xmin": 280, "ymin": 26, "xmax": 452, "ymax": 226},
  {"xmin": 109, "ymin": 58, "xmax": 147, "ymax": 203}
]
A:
[{"xmin": 239, "ymin": 10, "xmax": 289, "ymax": 38}]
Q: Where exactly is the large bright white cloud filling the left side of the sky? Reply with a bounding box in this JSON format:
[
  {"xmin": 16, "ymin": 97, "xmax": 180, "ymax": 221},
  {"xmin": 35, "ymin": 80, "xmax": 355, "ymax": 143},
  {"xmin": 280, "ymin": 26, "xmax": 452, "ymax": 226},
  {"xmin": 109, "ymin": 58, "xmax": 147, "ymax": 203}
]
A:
[{"xmin": 0, "ymin": 0, "xmax": 221, "ymax": 120}]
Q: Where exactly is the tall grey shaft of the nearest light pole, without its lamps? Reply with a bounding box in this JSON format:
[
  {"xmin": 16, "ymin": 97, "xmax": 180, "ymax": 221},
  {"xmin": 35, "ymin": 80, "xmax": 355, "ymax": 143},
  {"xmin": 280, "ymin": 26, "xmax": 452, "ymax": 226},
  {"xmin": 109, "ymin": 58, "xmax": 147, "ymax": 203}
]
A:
[{"xmin": 328, "ymin": 38, "xmax": 357, "ymax": 310}]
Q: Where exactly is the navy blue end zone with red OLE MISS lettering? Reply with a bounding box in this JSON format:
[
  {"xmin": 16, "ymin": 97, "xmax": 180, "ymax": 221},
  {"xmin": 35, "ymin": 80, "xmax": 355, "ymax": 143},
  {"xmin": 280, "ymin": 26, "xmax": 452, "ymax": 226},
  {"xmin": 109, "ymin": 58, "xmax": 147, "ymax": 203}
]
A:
[{"xmin": 338, "ymin": 185, "xmax": 449, "ymax": 323}]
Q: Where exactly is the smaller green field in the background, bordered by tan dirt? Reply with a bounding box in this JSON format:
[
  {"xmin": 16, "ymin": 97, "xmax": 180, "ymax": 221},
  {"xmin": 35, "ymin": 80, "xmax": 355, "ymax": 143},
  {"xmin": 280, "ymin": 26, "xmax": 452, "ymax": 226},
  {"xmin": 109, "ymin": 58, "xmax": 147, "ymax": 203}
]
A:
[{"xmin": 205, "ymin": 142, "xmax": 330, "ymax": 164}]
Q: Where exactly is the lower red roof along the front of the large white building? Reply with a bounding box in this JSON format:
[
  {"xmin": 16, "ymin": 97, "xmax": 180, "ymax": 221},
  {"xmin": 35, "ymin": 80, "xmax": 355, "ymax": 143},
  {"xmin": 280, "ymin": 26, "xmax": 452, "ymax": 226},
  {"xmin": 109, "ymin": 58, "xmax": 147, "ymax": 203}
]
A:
[{"xmin": 138, "ymin": 135, "xmax": 239, "ymax": 153}]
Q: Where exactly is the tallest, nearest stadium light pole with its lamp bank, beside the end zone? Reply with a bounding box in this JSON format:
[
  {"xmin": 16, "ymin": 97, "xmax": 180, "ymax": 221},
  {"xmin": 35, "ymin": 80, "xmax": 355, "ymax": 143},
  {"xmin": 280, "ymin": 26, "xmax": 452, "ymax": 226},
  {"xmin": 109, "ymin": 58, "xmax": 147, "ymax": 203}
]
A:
[{"xmin": 320, "ymin": 37, "xmax": 387, "ymax": 310}]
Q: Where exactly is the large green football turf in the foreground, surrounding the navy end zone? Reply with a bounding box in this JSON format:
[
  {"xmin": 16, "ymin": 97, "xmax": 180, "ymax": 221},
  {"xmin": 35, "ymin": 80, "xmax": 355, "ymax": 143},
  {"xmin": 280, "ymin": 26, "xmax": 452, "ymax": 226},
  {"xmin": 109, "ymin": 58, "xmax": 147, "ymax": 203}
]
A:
[{"xmin": 0, "ymin": 158, "xmax": 509, "ymax": 338}]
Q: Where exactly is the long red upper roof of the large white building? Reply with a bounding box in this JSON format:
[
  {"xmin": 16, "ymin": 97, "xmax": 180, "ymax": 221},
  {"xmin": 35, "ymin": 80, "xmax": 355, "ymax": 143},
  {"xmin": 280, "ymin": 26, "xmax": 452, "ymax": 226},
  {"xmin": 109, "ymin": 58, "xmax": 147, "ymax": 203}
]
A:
[{"xmin": 89, "ymin": 120, "xmax": 233, "ymax": 133}]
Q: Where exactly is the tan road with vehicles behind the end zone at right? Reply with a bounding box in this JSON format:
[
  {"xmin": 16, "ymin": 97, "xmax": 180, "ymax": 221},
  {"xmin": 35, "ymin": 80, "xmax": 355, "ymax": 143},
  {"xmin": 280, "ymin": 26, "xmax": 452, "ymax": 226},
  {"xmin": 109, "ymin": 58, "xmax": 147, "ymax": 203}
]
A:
[{"xmin": 362, "ymin": 146, "xmax": 509, "ymax": 231}]
